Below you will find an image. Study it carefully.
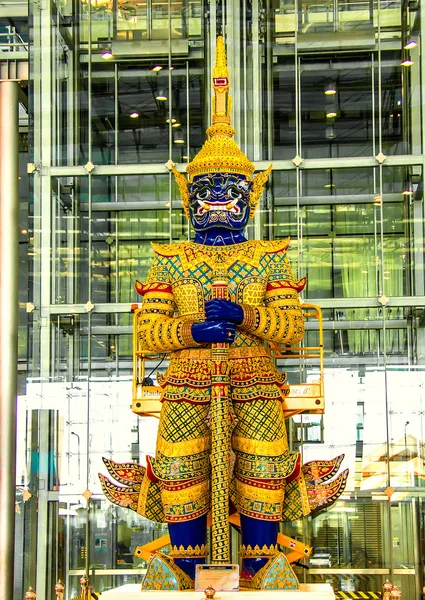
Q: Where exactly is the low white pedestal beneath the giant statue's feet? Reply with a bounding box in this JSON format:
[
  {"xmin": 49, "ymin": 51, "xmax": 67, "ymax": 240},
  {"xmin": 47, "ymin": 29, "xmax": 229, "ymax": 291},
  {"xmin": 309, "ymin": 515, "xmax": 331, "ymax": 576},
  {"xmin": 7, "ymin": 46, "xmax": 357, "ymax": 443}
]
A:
[{"xmin": 102, "ymin": 583, "xmax": 335, "ymax": 600}]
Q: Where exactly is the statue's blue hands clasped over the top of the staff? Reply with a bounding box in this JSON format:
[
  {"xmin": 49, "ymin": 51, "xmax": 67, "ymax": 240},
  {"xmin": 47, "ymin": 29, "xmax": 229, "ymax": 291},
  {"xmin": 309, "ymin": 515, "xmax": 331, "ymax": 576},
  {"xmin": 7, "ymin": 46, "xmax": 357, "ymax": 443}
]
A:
[{"xmin": 192, "ymin": 299, "xmax": 244, "ymax": 344}]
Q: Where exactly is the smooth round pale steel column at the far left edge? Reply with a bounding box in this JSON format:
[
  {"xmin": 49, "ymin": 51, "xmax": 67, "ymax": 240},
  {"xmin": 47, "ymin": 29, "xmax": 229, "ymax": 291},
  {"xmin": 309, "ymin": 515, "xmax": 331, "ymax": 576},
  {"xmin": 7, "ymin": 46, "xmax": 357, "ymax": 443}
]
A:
[{"xmin": 0, "ymin": 81, "xmax": 19, "ymax": 598}]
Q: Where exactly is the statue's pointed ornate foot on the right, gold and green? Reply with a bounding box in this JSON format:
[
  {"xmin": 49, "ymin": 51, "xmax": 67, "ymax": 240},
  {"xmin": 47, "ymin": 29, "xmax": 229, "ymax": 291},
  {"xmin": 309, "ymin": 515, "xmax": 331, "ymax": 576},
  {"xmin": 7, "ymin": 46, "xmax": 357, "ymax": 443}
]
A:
[{"xmin": 240, "ymin": 552, "xmax": 298, "ymax": 590}]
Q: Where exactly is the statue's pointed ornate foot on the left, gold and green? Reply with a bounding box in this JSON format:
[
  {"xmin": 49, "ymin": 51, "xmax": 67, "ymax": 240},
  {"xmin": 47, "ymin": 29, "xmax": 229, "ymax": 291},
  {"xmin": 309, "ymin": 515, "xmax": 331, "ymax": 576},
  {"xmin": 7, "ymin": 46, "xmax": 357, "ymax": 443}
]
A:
[{"xmin": 142, "ymin": 552, "xmax": 195, "ymax": 590}]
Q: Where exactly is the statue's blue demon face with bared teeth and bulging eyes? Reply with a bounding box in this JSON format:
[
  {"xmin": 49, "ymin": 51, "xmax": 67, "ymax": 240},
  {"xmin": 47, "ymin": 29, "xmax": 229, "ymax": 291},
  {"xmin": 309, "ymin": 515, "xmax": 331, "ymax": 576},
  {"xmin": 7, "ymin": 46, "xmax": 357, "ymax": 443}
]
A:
[{"xmin": 189, "ymin": 173, "xmax": 252, "ymax": 231}]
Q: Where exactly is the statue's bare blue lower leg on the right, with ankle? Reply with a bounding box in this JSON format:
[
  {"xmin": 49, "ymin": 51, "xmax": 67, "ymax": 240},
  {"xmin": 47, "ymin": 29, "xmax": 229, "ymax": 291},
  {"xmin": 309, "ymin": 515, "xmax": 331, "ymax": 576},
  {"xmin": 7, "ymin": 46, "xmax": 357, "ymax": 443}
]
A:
[{"xmin": 241, "ymin": 515, "xmax": 279, "ymax": 576}]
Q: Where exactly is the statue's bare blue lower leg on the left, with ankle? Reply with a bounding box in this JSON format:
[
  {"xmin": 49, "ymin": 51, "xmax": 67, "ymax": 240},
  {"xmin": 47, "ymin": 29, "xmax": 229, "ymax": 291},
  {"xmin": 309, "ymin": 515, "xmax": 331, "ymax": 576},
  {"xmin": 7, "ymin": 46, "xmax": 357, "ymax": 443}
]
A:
[{"xmin": 168, "ymin": 515, "xmax": 207, "ymax": 579}]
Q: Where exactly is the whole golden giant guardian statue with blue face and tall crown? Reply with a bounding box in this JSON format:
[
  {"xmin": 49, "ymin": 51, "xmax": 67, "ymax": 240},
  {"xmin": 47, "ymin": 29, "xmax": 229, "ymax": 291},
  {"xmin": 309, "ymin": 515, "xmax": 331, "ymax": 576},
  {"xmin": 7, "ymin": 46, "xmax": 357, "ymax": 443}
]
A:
[{"xmin": 101, "ymin": 37, "xmax": 347, "ymax": 589}]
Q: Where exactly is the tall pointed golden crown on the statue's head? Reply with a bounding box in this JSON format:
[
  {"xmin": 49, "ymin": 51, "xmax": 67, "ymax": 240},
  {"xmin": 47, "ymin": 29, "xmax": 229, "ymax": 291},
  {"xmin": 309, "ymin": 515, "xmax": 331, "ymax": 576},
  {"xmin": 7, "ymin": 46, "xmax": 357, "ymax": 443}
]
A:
[{"xmin": 186, "ymin": 36, "xmax": 255, "ymax": 181}]
